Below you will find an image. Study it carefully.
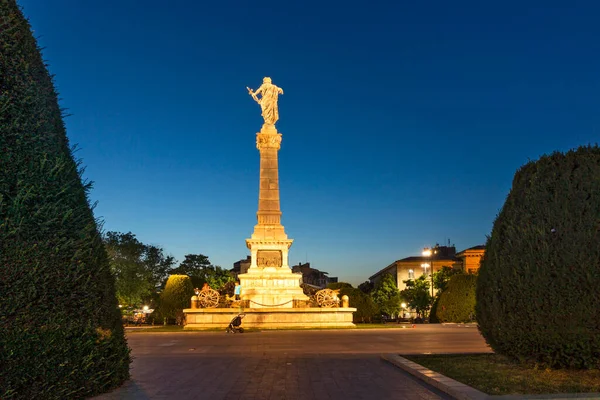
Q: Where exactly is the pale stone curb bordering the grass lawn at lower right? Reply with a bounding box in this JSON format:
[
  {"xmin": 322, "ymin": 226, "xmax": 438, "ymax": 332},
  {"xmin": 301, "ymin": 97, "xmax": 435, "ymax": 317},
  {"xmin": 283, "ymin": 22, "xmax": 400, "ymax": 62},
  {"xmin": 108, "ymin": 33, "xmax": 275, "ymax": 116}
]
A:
[{"xmin": 381, "ymin": 354, "xmax": 600, "ymax": 400}]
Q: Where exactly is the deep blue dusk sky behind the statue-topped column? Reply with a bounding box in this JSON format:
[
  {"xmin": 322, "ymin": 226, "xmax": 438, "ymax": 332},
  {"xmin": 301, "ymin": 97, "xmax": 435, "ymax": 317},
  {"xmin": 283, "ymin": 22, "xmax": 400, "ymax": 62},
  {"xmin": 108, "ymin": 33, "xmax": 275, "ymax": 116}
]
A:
[{"xmin": 20, "ymin": 0, "xmax": 600, "ymax": 284}]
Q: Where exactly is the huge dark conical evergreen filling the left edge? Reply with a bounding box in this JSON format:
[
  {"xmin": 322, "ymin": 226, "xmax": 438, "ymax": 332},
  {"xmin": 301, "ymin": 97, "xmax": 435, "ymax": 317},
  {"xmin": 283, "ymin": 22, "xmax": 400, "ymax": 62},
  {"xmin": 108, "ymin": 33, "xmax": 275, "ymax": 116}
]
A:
[{"xmin": 0, "ymin": 0, "xmax": 130, "ymax": 399}]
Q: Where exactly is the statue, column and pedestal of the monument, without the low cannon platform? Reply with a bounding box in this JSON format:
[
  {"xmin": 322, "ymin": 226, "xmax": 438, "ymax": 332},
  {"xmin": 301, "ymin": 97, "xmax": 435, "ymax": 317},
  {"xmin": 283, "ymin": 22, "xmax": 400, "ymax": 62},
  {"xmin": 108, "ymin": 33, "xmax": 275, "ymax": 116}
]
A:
[{"xmin": 238, "ymin": 78, "xmax": 308, "ymax": 308}]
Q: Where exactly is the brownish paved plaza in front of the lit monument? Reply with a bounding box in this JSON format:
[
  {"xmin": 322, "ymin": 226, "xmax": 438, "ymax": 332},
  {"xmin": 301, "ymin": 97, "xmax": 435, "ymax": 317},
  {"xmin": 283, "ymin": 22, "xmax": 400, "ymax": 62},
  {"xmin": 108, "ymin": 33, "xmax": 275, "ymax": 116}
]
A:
[{"xmin": 96, "ymin": 325, "xmax": 490, "ymax": 400}]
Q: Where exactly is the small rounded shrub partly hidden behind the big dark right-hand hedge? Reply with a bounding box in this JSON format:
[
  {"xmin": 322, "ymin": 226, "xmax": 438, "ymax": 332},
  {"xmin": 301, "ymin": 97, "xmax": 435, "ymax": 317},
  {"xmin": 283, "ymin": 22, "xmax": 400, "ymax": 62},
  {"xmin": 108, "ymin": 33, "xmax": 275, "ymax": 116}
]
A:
[{"xmin": 432, "ymin": 274, "xmax": 477, "ymax": 322}]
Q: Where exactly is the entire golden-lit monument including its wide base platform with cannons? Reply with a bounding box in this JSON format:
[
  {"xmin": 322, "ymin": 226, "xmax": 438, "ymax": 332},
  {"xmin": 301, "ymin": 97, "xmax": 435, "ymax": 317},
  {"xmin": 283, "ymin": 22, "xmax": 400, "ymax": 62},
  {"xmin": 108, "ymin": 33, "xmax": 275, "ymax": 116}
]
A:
[{"xmin": 183, "ymin": 78, "xmax": 356, "ymax": 330}]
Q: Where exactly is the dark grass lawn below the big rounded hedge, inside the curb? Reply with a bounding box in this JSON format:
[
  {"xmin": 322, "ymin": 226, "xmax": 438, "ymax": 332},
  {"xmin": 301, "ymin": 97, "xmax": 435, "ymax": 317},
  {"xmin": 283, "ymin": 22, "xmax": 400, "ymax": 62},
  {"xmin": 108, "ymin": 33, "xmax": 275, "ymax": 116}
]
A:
[{"xmin": 402, "ymin": 354, "xmax": 600, "ymax": 395}]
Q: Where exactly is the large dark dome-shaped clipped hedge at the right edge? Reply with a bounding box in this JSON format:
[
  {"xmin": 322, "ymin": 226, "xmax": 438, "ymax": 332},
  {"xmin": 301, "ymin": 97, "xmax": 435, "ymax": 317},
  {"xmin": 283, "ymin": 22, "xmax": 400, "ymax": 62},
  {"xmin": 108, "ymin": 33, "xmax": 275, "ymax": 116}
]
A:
[{"xmin": 476, "ymin": 145, "xmax": 600, "ymax": 368}]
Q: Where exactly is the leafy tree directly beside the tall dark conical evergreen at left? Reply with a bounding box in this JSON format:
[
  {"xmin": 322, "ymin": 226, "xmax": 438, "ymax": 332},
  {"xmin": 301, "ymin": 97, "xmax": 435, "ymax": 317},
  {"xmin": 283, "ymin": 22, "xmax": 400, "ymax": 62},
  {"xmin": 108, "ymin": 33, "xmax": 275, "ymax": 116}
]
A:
[{"xmin": 104, "ymin": 232, "xmax": 175, "ymax": 306}]
